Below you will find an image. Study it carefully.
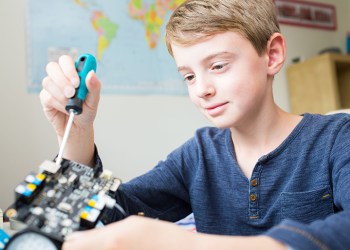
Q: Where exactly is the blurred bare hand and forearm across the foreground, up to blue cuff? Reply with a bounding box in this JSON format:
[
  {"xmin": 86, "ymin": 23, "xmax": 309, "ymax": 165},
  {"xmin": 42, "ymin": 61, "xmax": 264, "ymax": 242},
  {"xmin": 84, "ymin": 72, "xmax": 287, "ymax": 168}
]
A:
[{"xmin": 62, "ymin": 216, "xmax": 287, "ymax": 250}]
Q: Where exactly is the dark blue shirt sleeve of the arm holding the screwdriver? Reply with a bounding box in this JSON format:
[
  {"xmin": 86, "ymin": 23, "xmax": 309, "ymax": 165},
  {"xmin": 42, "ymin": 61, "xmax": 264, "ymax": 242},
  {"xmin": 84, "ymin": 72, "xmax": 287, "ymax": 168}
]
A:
[{"xmin": 104, "ymin": 140, "xmax": 197, "ymax": 222}]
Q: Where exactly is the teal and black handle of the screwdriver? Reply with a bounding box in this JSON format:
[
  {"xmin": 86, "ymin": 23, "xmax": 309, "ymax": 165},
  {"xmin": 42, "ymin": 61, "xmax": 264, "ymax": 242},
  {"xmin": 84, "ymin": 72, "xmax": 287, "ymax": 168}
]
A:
[{"xmin": 66, "ymin": 54, "xmax": 97, "ymax": 115}]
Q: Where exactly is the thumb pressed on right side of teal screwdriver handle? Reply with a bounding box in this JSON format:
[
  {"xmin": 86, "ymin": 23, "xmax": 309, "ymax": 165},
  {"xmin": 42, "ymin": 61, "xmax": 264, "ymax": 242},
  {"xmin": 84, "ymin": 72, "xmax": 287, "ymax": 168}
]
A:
[{"xmin": 85, "ymin": 70, "xmax": 101, "ymax": 109}]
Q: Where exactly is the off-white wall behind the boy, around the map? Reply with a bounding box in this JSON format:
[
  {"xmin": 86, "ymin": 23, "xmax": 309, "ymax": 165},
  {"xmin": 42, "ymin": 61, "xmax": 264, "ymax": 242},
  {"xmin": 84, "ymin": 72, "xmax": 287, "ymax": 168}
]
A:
[{"xmin": 0, "ymin": 0, "xmax": 350, "ymax": 209}]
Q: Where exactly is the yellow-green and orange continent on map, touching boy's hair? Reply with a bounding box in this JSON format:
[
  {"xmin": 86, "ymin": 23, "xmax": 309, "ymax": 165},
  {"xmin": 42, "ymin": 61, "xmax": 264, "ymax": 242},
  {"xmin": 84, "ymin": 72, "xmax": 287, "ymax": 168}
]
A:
[{"xmin": 129, "ymin": 0, "xmax": 185, "ymax": 49}]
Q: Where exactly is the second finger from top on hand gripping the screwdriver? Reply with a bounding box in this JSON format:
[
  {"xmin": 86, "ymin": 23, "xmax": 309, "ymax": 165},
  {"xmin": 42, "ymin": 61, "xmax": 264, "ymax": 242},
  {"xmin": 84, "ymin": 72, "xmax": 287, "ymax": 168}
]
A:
[{"xmin": 46, "ymin": 62, "xmax": 75, "ymax": 98}]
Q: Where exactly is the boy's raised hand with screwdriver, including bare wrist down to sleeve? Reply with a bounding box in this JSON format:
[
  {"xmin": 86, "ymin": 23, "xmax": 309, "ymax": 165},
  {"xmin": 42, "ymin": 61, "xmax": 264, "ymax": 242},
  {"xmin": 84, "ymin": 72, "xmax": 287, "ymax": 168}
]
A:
[{"xmin": 40, "ymin": 56, "xmax": 101, "ymax": 165}]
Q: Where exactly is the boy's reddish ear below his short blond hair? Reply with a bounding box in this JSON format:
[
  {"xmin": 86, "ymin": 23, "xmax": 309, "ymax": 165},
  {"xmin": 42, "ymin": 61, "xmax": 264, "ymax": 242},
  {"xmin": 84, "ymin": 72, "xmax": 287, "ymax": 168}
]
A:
[{"xmin": 267, "ymin": 33, "xmax": 286, "ymax": 76}]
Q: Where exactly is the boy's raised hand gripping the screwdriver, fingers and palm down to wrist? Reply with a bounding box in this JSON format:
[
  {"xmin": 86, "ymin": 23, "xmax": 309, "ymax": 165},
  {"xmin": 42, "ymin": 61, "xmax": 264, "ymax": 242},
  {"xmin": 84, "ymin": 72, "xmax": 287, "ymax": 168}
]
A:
[{"xmin": 40, "ymin": 56, "xmax": 101, "ymax": 137}]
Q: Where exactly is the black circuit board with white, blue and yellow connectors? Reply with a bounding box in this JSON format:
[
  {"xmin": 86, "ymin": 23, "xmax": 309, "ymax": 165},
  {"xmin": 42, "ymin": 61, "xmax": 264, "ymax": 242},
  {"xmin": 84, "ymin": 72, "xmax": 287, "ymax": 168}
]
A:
[{"xmin": 6, "ymin": 160, "xmax": 121, "ymax": 242}]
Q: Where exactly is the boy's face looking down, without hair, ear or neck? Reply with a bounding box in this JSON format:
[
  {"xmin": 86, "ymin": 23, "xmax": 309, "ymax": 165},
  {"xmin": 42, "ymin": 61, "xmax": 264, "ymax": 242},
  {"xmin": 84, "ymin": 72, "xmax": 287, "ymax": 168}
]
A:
[{"xmin": 172, "ymin": 32, "xmax": 272, "ymax": 128}]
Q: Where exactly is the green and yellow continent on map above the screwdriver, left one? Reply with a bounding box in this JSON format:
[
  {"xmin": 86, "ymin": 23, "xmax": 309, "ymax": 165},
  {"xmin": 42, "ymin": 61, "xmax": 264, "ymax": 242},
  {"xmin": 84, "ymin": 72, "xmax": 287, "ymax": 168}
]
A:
[{"xmin": 92, "ymin": 11, "xmax": 118, "ymax": 61}]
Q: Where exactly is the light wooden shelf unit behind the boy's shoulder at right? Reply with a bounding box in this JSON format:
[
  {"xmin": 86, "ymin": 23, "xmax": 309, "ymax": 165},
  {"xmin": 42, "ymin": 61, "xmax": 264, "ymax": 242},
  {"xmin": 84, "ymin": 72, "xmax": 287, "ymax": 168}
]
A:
[{"xmin": 287, "ymin": 54, "xmax": 350, "ymax": 114}]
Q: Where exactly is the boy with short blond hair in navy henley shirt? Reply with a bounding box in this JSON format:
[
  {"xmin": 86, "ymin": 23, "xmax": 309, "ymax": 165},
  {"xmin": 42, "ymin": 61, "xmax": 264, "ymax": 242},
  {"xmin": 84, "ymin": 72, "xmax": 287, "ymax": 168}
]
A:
[{"xmin": 40, "ymin": 0, "xmax": 350, "ymax": 249}]
